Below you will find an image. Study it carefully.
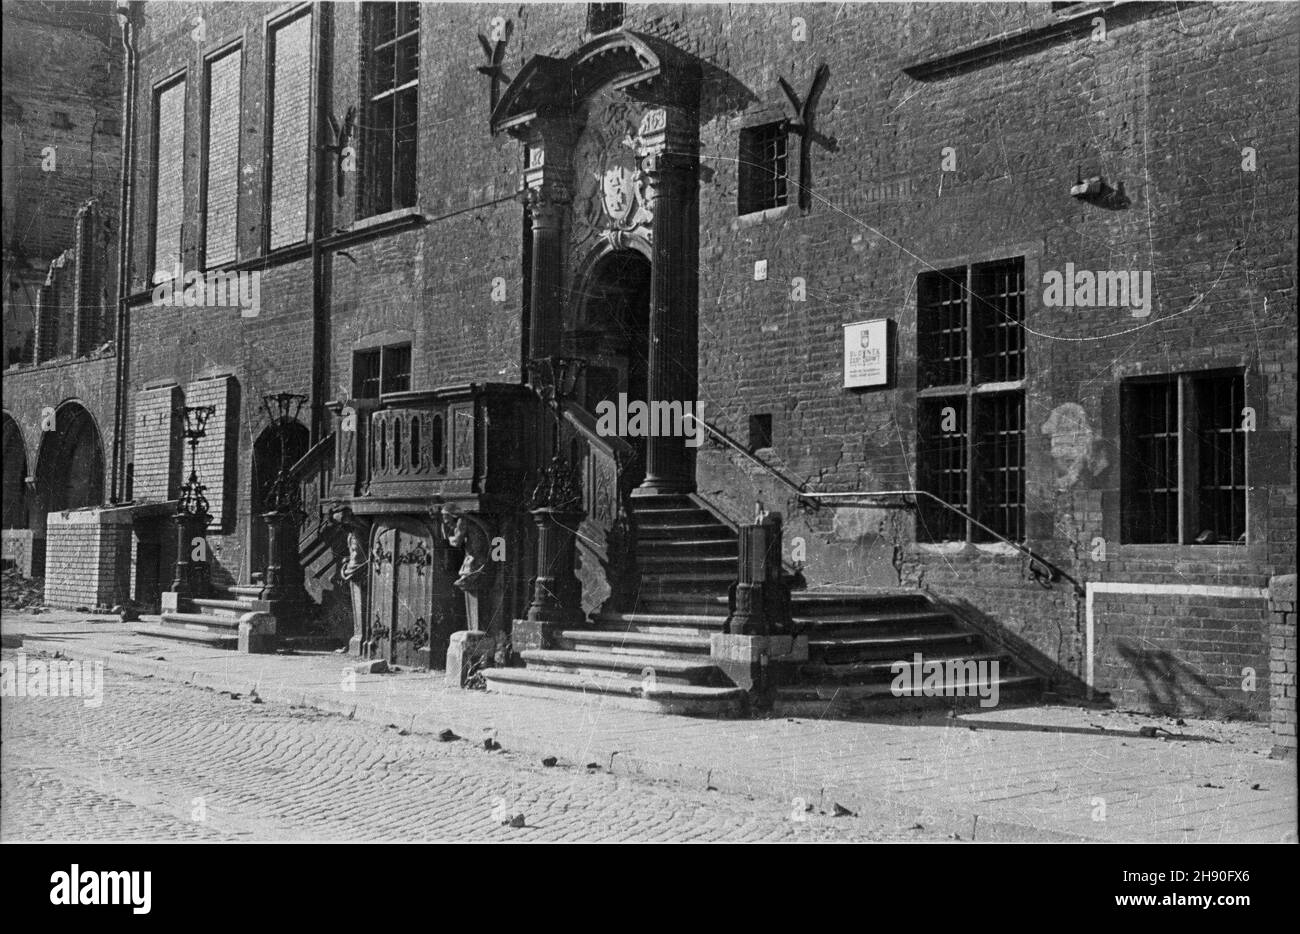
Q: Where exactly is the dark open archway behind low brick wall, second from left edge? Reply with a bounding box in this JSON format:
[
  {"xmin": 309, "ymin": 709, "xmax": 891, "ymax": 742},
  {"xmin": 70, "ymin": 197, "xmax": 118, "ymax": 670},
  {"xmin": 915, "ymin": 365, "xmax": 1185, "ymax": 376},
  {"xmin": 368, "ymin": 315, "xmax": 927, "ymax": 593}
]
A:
[{"xmin": 29, "ymin": 402, "xmax": 104, "ymax": 576}]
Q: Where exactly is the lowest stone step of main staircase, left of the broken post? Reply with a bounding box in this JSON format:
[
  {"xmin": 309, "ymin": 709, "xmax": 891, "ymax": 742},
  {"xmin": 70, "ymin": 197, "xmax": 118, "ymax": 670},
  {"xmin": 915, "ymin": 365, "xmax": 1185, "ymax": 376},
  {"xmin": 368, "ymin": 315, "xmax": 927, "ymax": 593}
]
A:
[{"xmin": 484, "ymin": 669, "xmax": 745, "ymax": 717}]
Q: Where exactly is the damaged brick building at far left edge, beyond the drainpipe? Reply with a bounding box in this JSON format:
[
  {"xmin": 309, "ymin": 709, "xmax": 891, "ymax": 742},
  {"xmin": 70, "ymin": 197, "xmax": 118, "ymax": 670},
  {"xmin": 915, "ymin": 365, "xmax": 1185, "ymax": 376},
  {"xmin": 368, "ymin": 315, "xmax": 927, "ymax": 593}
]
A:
[{"xmin": 3, "ymin": 3, "xmax": 122, "ymax": 582}]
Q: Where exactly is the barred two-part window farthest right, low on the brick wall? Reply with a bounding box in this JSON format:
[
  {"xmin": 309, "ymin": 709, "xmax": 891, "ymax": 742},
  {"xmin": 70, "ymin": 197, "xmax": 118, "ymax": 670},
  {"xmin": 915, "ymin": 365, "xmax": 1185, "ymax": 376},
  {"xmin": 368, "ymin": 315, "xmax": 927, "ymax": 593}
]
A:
[{"xmin": 1121, "ymin": 372, "xmax": 1247, "ymax": 545}]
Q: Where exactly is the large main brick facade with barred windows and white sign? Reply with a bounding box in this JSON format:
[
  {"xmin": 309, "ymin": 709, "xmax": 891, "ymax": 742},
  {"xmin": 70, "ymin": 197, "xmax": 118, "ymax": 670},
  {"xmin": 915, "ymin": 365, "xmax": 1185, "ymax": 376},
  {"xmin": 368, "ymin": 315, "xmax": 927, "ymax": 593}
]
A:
[{"xmin": 7, "ymin": 3, "xmax": 1300, "ymax": 717}]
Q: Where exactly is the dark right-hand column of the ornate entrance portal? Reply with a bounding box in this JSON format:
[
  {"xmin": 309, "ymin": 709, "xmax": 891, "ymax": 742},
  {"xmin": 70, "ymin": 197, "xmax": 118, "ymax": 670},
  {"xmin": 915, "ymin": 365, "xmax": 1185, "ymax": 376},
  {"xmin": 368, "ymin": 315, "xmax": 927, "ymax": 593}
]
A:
[{"xmin": 633, "ymin": 107, "xmax": 699, "ymax": 496}]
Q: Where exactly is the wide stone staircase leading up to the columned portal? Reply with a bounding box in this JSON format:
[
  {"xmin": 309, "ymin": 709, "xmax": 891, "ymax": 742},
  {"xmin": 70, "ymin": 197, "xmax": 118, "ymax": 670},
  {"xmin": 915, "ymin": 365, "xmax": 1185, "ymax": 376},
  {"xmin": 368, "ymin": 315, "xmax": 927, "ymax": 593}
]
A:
[{"xmin": 485, "ymin": 496, "xmax": 1041, "ymax": 715}]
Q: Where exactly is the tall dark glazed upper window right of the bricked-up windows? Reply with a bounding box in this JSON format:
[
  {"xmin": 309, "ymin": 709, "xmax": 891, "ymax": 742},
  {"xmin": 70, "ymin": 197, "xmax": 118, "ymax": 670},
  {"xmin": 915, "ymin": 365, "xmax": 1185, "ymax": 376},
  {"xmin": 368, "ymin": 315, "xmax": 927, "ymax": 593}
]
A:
[{"xmin": 359, "ymin": 3, "xmax": 420, "ymax": 216}]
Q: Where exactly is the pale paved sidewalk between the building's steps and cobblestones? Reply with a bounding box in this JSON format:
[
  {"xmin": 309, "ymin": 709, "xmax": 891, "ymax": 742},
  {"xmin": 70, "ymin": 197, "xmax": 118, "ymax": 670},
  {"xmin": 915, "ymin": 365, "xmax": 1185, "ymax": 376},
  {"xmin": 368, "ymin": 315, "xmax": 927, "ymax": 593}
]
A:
[{"xmin": 3, "ymin": 611, "xmax": 1296, "ymax": 842}]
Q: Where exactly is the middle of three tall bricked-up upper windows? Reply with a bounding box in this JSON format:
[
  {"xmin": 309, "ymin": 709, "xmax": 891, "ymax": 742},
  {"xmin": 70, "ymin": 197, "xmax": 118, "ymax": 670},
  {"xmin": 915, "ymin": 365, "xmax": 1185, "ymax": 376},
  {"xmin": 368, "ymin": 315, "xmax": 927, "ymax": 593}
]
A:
[{"xmin": 203, "ymin": 48, "xmax": 243, "ymax": 267}]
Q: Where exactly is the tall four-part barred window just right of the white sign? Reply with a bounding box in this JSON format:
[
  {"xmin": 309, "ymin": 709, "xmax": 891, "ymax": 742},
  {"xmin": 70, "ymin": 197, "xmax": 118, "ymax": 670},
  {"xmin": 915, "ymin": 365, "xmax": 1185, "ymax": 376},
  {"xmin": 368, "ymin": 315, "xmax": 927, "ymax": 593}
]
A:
[{"xmin": 917, "ymin": 258, "xmax": 1024, "ymax": 541}]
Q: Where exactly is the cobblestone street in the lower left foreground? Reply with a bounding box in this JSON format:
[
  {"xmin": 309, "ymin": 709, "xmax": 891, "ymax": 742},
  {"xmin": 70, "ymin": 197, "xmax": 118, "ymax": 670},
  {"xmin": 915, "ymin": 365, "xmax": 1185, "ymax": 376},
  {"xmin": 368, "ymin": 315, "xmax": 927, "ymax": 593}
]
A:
[{"xmin": 0, "ymin": 653, "xmax": 933, "ymax": 842}]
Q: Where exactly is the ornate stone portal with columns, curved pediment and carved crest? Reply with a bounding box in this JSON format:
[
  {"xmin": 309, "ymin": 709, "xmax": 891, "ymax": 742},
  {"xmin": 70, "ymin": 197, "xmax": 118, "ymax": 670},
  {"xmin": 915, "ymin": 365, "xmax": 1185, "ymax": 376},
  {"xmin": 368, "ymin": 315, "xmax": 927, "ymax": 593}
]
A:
[{"xmin": 491, "ymin": 33, "xmax": 702, "ymax": 652}]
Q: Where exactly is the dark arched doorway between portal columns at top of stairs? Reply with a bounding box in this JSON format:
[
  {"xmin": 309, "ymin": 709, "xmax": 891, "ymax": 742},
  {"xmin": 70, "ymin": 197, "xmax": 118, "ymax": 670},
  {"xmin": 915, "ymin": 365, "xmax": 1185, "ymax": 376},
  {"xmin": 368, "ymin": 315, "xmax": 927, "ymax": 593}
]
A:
[{"xmin": 577, "ymin": 250, "xmax": 650, "ymax": 483}]
